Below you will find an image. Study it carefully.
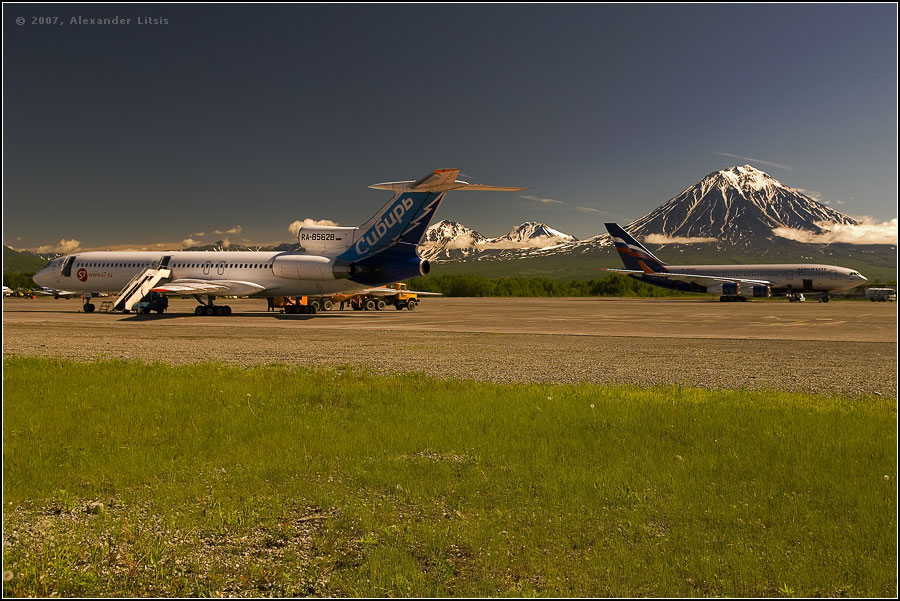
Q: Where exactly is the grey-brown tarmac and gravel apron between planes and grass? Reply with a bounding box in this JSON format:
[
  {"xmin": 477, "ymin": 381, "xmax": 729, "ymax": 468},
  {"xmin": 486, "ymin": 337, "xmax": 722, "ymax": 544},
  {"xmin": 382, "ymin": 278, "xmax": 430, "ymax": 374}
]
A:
[{"xmin": 3, "ymin": 298, "xmax": 897, "ymax": 396}]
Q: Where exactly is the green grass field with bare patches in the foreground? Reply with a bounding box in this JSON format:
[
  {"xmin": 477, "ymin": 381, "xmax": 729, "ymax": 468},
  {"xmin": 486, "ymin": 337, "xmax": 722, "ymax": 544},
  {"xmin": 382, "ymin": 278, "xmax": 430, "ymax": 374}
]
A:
[{"xmin": 3, "ymin": 358, "xmax": 897, "ymax": 597}]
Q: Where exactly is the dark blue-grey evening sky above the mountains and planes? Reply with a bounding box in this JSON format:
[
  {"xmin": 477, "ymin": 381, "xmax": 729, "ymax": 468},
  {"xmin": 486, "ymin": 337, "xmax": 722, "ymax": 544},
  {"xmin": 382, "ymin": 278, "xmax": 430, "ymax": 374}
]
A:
[{"xmin": 3, "ymin": 4, "xmax": 897, "ymax": 248}]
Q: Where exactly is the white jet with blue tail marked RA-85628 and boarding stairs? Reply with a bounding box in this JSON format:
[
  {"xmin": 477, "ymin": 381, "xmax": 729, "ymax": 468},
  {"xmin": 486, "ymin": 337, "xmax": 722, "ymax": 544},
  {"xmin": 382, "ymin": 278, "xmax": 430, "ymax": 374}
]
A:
[{"xmin": 33, "ymin": 169, "xmax": 527, "ymax": 315}]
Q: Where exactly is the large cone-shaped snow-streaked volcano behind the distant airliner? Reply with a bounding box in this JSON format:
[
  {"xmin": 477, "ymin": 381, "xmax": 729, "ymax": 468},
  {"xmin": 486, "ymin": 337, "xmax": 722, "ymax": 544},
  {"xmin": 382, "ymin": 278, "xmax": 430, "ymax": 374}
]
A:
[{"xmin": 626, "ymin": 165, "xmax": 858, "ymax": 245}]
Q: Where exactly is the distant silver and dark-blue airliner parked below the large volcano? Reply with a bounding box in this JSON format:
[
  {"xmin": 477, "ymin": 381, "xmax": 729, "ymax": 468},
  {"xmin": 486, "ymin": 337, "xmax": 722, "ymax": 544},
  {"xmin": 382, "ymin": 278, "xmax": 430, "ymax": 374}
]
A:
[{"xmin": 606, "ymin": 223, "xmax": 866, "ymax": 302}]
